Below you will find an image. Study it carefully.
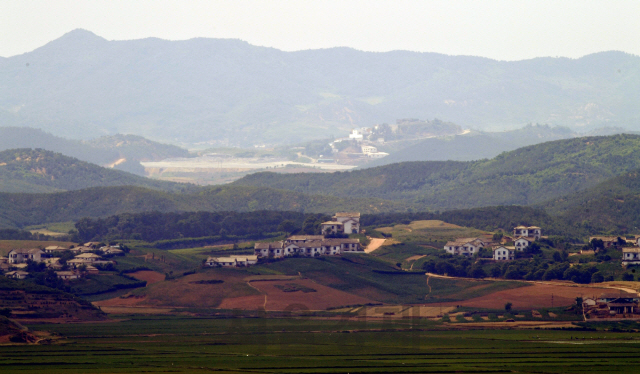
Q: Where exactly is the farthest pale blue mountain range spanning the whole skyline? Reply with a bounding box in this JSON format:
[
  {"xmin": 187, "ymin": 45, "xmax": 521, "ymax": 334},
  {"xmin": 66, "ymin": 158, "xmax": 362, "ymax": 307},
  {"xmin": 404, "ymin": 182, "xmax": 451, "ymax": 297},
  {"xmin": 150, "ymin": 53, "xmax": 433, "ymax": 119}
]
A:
[{"xmin": 0, "ymin": 30, "xmax": 640, "ymax": 144}]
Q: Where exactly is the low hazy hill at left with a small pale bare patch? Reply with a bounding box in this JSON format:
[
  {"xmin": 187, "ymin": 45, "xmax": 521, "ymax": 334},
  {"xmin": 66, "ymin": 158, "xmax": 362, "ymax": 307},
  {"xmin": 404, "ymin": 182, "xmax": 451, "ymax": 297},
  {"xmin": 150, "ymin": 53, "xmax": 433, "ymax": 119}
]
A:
[{"xmin": 0, "ymin": 127, "xmax": 189, "ymax": 174}]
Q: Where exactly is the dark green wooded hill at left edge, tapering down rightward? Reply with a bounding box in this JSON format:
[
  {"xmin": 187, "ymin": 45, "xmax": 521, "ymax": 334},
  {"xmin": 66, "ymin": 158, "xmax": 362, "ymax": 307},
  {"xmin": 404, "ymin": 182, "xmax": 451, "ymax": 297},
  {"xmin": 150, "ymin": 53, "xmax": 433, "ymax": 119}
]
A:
[{"xmin": 0, "ymin": 148, "xmax": 196, "ymax": 192}]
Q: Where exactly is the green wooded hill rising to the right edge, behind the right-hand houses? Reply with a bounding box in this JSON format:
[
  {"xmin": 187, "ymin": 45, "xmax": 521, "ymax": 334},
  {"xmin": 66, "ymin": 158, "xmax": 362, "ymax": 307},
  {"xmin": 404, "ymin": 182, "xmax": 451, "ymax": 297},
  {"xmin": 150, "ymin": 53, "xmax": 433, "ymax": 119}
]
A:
[{"xmin": 234, "ymin": 135, "xmax": 640, "ymax": 209}]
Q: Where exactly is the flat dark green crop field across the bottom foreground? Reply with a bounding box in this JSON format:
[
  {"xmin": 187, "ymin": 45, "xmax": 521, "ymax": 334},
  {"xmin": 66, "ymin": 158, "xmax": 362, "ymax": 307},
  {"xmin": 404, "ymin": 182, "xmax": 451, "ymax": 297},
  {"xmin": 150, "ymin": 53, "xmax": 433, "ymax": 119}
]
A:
[{"xmin": 7, "ymin": 316, "xmax": 640, "ymax": 374}]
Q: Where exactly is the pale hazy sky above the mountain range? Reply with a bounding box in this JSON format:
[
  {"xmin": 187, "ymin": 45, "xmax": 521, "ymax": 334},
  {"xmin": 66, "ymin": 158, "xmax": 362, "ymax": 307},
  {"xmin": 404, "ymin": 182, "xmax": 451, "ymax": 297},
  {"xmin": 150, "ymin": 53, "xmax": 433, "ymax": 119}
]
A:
[{"xmin": 0, "ymin": 0, "xmax": 640, "ymax": 60}]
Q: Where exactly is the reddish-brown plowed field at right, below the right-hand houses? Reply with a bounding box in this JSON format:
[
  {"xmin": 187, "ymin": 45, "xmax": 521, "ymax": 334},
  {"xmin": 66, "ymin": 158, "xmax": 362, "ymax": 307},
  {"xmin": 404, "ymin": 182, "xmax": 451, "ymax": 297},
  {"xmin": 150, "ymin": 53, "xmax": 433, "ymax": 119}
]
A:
[{"xmin": 447, "ymin": 284, "xmax": 613, "ymax": 309}]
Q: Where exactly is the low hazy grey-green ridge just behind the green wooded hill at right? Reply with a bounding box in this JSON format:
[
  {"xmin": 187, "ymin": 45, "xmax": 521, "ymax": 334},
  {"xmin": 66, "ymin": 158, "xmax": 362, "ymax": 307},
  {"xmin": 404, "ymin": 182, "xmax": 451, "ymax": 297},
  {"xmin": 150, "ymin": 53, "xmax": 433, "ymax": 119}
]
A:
[{"xmin": 365, "ymin": 125, "xmax": 576, "ymax": 167}]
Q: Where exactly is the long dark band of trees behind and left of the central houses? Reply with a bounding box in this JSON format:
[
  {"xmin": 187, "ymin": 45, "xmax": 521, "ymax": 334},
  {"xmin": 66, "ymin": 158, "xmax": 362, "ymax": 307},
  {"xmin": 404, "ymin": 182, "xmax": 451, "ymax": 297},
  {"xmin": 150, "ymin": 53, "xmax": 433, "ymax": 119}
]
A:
[{"xmin": 76, "ymin": 211, "xmax": 329, "ymax": 242}]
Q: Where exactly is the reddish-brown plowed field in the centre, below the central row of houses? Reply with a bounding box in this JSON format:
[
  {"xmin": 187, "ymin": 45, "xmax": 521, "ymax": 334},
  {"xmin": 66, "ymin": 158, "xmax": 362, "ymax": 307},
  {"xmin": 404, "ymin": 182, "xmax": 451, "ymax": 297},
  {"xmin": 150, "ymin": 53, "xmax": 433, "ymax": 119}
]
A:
[{"xmin": 248, "ymin": 279, "xmax": 376, "ymax": 310}]
